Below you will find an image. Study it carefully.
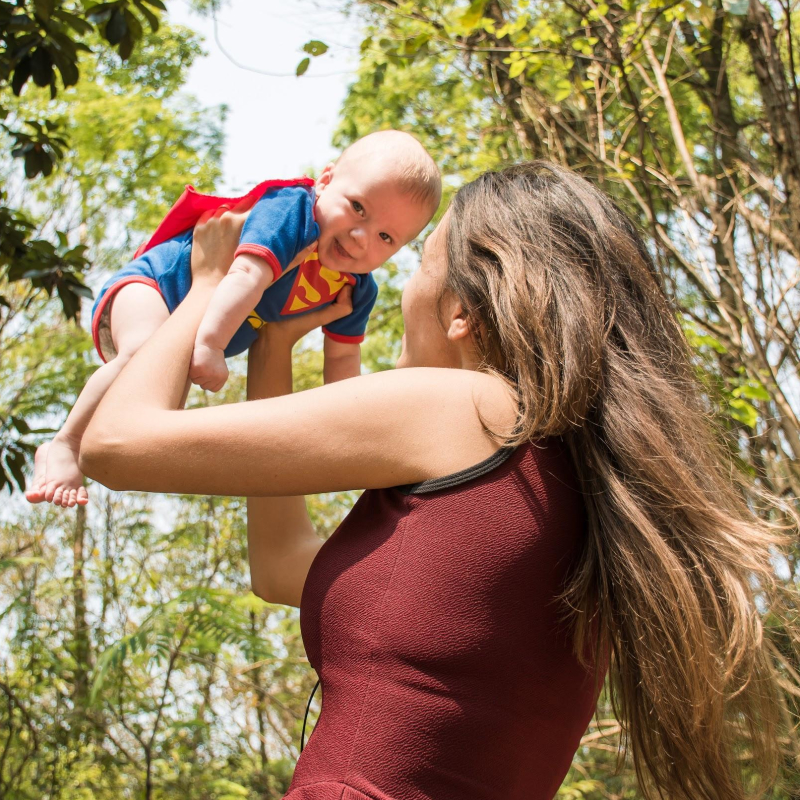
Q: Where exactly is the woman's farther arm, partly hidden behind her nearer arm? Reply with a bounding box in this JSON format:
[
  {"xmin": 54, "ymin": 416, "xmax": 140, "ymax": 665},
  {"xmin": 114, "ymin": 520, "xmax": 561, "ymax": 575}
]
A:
[{"xmin": 247, "ymin": 288, "xmax": 352, "ymax": 606}]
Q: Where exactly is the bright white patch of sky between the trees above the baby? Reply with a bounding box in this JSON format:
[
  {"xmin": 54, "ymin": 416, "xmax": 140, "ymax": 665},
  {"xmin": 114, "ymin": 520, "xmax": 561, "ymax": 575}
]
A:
[{"xmin": 167, "ymin": 0, "xmax": 360, "ymax": 193}]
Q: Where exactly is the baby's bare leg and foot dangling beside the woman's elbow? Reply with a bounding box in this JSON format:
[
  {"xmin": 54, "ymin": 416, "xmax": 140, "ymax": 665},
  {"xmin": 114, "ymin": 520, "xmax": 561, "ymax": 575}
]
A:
[{"xmin": 25, "ymin": 283, "xmax": 169, "ymax": 508}]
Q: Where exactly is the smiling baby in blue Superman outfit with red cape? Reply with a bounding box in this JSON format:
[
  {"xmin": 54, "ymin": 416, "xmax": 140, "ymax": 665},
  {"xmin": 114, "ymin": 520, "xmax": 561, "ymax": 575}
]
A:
[{"xmin": 25, "ymin": 131, "xmax": 441, "ymax": 507}]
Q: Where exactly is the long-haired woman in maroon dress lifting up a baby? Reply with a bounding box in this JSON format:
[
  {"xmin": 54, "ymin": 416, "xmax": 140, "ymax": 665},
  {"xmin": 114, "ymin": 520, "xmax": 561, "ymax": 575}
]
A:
[{"xmin": 82, "ymin": 162, "xmax": 792, "ymax": 800}]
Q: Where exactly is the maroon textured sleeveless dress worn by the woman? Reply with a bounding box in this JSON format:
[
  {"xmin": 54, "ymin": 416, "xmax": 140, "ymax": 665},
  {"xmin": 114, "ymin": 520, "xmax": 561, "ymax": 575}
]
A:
[{"xmin": 285, "ymin": 440, "xmax": 599, "ymax": 800}]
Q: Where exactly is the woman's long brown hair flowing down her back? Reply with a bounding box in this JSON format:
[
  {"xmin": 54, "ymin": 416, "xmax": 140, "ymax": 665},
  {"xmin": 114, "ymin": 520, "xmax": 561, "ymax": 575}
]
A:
[{"xmin": 444, "ymin": 162, "xmax": 796, "ymax": 800}]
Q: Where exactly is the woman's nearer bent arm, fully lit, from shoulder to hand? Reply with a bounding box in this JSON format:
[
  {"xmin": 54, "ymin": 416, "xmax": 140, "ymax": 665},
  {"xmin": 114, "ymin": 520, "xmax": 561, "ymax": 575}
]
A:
[{"xmin": 81, "ymin": 206, "xmax": 514, "ymax": 497}]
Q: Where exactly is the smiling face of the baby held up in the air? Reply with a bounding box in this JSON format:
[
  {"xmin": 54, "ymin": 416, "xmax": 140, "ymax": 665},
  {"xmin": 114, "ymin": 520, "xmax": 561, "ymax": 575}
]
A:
[{"xmin": 315, "ymin": 163, "xmax": 432, "ymax": 273}]
